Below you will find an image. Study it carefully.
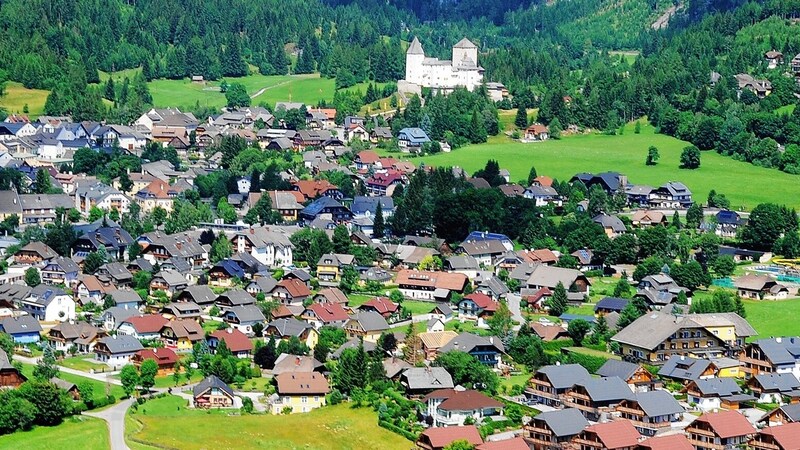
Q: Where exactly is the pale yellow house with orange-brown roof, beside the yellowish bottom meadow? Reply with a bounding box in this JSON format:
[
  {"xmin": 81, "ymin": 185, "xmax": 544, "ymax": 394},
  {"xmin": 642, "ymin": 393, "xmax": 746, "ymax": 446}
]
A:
[{"xmin": 270, "ymin": 372, "xmax": 330, "ymax": 414}]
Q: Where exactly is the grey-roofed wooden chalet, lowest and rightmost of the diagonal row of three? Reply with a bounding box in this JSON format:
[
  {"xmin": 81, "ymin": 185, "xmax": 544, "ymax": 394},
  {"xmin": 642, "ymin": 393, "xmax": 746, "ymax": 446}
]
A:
[{"xmin": 616, "ymin": 390, "xmax": 684, "ymax": 436}]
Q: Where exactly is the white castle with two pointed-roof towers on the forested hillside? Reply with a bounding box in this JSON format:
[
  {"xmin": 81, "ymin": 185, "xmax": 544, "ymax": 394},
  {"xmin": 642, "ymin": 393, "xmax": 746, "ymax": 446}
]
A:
[{"xmin": 398, "ymin": 37, "xmax": 483, "ymax": 93}]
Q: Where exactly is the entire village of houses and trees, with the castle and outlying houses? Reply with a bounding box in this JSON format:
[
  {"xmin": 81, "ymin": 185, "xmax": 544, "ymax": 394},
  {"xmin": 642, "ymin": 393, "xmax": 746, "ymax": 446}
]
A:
[{"xmin": 0, "ymin": 30, "xmax": 800, "ymax": 450}]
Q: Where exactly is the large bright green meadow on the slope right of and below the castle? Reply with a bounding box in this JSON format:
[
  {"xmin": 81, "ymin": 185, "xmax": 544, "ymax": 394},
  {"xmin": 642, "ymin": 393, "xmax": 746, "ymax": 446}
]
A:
[{"xmin": 380, "ymin": 121, "xmax": 800, "ymax": 209}]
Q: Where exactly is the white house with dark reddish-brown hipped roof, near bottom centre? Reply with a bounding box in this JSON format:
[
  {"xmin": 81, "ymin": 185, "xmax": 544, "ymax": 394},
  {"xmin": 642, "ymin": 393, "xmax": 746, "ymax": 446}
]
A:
[{"xmin": 423, "ymin": 389, "xmax": 504, "ymax": 427}]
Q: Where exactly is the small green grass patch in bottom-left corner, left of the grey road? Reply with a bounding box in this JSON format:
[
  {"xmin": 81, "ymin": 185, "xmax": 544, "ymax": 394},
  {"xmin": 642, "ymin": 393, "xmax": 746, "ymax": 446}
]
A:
[{"xmin": 0, "ymin": 416, "xmax": 110, "ymax": 450}]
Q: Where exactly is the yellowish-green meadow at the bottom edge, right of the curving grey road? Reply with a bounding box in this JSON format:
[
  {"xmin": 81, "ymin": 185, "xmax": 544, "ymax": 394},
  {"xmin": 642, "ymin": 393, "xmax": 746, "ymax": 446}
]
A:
[{"xmin": 128, "ymin": 396, "xmax": 413, "ymax": 450}]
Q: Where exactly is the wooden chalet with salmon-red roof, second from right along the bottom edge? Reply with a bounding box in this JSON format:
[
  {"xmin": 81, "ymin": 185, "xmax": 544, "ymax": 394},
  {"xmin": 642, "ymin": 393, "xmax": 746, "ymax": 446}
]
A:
[{"xmin": 686, "ymin": 411, "xmax": 756, "ymax": 450}]
